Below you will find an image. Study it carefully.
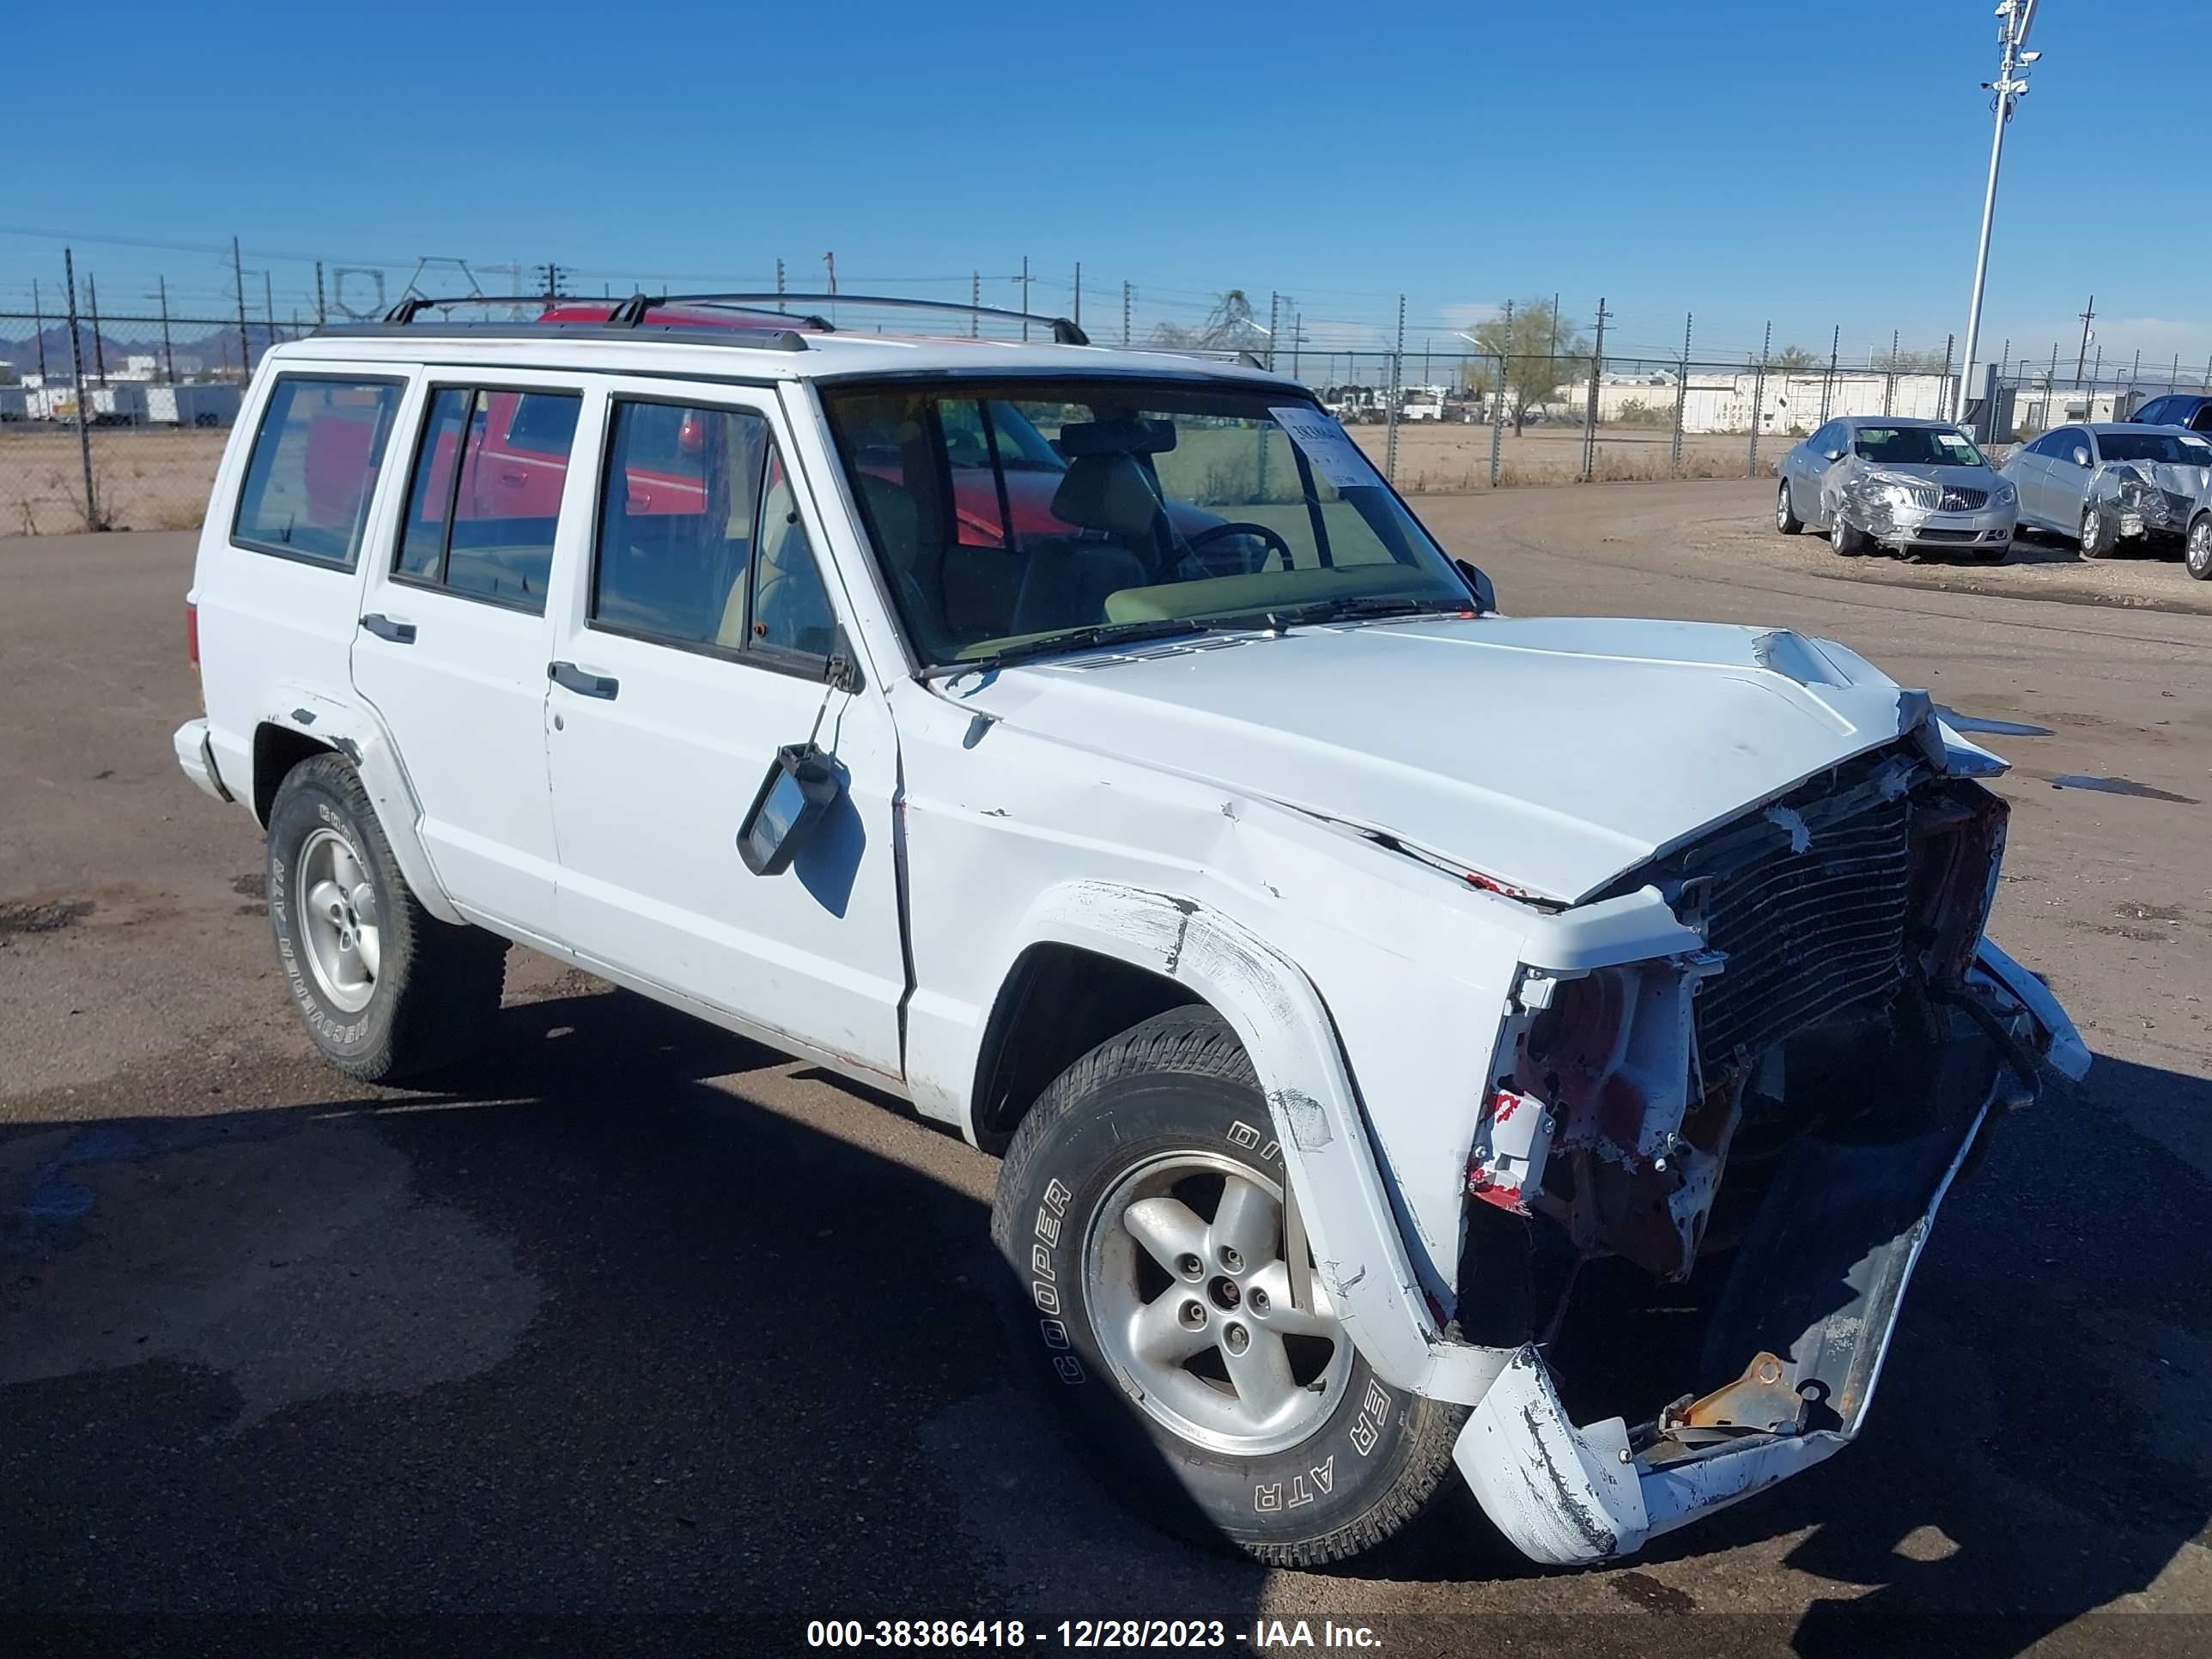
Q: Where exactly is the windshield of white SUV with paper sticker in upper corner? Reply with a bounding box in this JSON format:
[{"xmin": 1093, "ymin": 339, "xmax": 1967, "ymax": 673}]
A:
[{"xmin": 823, "ymin": 376, "xmax": 1468, "ymax": 665}]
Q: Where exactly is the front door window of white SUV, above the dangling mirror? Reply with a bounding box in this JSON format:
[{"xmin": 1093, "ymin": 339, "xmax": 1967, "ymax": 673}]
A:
[{"xmin": 591, "ymin": 398, "xmax": 836, "ymax": 665}]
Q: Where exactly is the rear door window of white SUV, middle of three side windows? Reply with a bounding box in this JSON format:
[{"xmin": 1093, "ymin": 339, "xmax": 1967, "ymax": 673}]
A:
[{"xmin": 392, "ymin": 387, "xmax": 584, "ymax": 615}]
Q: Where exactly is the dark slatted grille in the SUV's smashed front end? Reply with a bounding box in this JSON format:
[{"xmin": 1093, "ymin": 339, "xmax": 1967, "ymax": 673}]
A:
[{"xmin": 1697, "ymin": 796, "xmax": 1911, "ymax": 1071}]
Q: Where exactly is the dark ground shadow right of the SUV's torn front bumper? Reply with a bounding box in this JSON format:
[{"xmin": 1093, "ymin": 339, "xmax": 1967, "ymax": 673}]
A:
[{"xmin": 1650, "ymin": 1060, "xmax": 2212, "ymax": 1659}]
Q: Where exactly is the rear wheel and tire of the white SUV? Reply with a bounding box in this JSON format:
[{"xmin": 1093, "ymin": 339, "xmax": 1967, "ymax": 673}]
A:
[{"xmin": 268, "ymin": 754, "xmax": 507, "ymax": 1084}]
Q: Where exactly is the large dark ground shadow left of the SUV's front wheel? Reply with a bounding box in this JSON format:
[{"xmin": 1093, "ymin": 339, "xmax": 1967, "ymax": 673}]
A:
[{"xmin": 0, "ymin": 994, "xmax": 1263, "ymax": 1652}]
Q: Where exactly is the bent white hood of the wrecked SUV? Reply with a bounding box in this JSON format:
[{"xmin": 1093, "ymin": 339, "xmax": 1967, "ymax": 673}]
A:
[{"xmin": 947, "ymin": 617, "xmax": 1929, "ymax": 902}]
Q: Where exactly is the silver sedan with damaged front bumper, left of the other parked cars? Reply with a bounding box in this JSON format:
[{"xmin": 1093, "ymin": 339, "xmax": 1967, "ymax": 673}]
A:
[{"xmin": 1774, "ymin": 416, "xmax": 2017, "ymax": 564}]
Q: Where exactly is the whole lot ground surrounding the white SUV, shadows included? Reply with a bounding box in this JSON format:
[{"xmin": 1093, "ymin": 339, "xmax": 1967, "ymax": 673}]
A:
[{"xmin": 0, "ymin": 483, "xmax": 2212, "ymax": 1659}]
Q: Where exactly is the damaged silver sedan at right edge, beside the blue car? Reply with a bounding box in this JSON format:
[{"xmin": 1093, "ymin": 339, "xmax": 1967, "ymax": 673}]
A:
[{"xmin": 2004, "ymin": 420, "xmax": 2212, "ymax": 575}]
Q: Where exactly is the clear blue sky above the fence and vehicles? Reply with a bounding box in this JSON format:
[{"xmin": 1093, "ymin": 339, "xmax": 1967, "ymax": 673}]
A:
[{"xmin": 0, "ymin": 0, "xmax": 2212, "ymax": 369}]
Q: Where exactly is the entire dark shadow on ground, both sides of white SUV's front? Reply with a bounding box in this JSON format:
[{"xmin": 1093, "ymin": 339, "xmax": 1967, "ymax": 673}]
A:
[{"xmin": 0, "ymin": 994, "xmax": 2212, "ymax": 1659}]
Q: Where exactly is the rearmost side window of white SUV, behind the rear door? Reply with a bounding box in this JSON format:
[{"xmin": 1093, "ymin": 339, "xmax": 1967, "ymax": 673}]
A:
[{"xmin": 230, "ymin": 374, "xmax": 400, "ymax": 571}]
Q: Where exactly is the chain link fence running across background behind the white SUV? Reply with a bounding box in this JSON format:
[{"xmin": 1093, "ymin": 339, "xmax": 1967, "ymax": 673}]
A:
[{"xmin": 0, "ymin": 288, "xmax": 2212, "ymax": 535}]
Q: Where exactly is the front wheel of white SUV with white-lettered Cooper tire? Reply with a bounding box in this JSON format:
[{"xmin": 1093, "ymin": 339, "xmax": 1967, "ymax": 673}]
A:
[{"xmin": 991, "ymin": 1009, "xmax": 1467, "ymax": 1566}]
